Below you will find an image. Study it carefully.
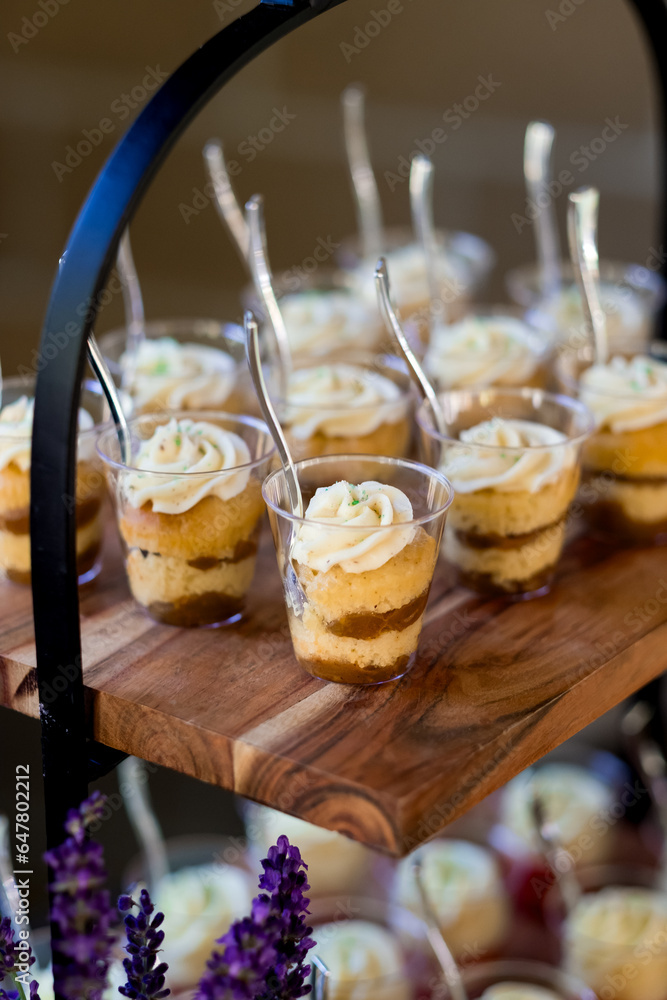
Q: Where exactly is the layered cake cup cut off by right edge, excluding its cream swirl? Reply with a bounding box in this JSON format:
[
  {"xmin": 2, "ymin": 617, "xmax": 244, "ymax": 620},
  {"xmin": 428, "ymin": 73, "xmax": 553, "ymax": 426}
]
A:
[{"xmin": 556, "ymin": 342, "xmax": 667, "ymax": 546}]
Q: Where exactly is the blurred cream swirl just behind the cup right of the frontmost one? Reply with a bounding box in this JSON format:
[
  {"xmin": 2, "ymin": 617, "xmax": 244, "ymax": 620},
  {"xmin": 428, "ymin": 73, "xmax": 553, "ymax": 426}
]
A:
[{"xmin": 424, "ymin": 315, "xmax": 544, "ymax": 389}]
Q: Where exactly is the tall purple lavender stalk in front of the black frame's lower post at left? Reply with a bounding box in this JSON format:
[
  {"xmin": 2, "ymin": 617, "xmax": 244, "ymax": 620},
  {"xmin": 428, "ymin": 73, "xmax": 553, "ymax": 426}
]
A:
[{"xmin": 44, "ymin": 792, "xmax": 116, "ymax": 1000}]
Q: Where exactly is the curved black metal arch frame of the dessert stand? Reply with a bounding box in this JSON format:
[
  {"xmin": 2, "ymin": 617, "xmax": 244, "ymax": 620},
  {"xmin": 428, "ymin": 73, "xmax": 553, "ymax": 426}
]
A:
[{"xmin": 30, "ymin": 0, "xmax": 667, "ymax": 984}]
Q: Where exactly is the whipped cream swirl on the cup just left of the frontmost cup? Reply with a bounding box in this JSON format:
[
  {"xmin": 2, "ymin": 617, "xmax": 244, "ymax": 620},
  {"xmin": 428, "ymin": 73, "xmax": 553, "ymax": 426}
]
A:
[{"xmin": 124, "ymin": 418, "xmax": 250, "ymax": 514}]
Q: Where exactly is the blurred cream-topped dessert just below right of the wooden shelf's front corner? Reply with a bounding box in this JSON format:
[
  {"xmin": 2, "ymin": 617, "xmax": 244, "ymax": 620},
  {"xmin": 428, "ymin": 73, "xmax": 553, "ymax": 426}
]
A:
[{"xmin": 396, "ymin": 839, "xmax": 511, "ymax": 964}]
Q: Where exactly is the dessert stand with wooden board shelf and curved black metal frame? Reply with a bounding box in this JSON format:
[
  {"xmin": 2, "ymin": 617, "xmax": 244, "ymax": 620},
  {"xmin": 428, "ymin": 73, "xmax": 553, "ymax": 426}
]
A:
[{"xmin": 0, "ymin": 0, "xmax": 667, "ymax": 952}]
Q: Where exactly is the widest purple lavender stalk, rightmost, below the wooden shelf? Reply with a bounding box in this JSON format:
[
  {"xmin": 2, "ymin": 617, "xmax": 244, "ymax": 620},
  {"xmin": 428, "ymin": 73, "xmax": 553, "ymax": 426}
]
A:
[{"xmin": 196, "ymin": 836, "xmax": 315, "ymax": 1000}]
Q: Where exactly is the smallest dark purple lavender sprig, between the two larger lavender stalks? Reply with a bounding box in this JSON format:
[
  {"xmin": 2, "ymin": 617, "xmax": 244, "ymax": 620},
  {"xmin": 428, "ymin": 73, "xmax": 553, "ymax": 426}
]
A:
[{"xmin": 118, "ymin": 889, "xmax": 171, "ymax": 1000}]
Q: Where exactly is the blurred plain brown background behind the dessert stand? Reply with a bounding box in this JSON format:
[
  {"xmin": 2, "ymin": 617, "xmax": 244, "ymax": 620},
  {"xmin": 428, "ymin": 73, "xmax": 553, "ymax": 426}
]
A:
[{"xmin": 0, "ymin": 0, "xmax": 659, "ymax": 924}]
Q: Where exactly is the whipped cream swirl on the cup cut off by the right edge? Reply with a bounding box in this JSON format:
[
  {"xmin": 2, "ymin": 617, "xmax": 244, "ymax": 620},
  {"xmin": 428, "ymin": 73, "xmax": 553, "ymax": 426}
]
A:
[{"xmin": 579, "ymin": 354, "xmax": 667, "ymax": 432}]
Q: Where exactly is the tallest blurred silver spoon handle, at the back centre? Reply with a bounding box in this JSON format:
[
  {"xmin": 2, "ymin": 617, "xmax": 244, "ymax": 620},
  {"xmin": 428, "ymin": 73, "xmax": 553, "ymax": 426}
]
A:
[{"xmin": 341, "ymin": 84, "xmax": 383, "ymax": 260}]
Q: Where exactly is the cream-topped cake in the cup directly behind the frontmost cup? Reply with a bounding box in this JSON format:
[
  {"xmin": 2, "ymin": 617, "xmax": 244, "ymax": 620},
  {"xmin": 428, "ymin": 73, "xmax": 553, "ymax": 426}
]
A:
[{"xmin": 272, "ymin": 353, "xmax": 415, "ymax": 470}]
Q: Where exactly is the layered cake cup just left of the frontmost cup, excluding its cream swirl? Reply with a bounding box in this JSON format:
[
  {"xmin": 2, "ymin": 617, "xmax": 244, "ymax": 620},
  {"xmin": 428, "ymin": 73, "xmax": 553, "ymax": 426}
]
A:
[{"xmin": 98, "ymin": 411, "xmax": 274, "ymax": 628}]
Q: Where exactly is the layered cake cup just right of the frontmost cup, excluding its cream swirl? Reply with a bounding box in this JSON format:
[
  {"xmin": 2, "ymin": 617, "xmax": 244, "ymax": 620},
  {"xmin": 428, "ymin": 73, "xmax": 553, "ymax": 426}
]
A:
[{"xmin": 417, "ymin": 388, "xmax": 592, "ymax": 598}]
